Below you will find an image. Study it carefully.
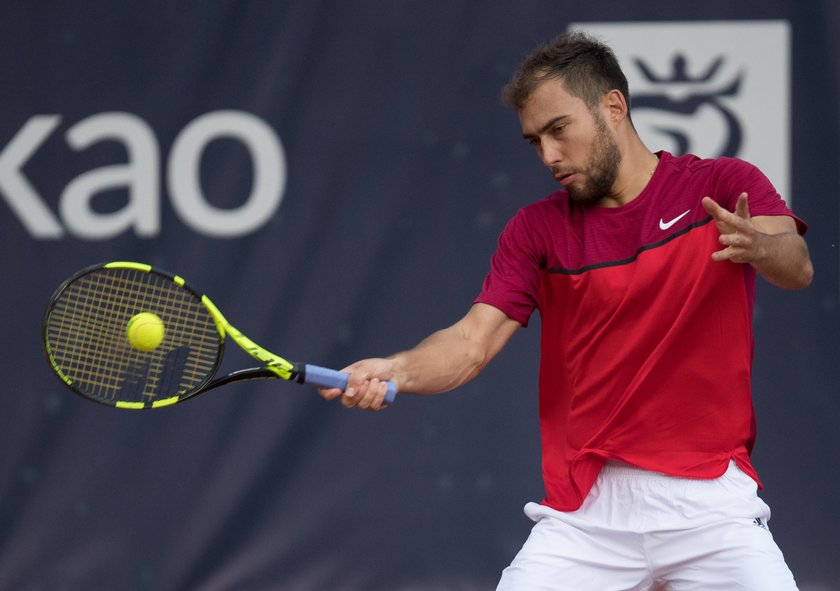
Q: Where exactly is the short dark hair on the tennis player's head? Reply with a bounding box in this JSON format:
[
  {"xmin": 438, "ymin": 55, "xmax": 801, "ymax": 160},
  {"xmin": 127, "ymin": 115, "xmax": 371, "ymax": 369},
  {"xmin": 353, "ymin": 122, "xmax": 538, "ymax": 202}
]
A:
[{"xmin": 502, "ymin": 31, "xmax": 630, "ymax": 115}]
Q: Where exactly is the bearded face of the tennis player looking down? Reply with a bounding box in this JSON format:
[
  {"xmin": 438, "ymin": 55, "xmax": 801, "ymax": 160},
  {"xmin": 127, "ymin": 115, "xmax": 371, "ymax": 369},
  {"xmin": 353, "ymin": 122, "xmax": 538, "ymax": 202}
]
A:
[{"xmin": 519, "ymin": 79, "xmax": 621, "ymax": 205}]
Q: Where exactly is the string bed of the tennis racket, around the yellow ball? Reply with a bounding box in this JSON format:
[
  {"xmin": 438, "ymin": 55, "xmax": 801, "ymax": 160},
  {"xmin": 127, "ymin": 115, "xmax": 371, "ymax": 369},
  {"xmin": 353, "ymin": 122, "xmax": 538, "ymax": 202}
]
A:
[{"xmin": 46, "ymin": 268, "xmax": 221, "ymax": 403}]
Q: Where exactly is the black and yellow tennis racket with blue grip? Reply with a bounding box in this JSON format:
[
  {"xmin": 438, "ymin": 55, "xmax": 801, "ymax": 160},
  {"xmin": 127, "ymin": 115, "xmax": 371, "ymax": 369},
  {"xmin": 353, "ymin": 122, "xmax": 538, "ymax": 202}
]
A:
[{"xmin": 43, "ymin": 262, "xmax": 396, "ymax": 409}]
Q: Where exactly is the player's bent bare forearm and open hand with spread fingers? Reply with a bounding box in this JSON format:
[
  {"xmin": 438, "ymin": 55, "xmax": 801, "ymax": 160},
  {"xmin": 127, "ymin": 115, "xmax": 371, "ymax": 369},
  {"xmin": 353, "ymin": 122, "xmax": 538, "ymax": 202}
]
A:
[{"xmin": 703, "ymin": 193, "xmax": 814, "ymax": 289}]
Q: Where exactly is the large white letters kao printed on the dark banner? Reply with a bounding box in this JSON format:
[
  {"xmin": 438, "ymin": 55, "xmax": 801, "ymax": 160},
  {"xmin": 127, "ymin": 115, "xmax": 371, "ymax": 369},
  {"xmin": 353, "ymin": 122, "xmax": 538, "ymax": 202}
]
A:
[{"xmin": 0, "ymin": 111, "xmax": 286, "ymax": 240}]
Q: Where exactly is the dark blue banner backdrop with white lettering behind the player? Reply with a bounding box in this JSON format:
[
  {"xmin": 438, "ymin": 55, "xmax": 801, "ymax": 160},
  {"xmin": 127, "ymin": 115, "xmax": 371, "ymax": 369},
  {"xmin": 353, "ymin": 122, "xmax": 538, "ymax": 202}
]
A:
[{"xmin": 0, "ymin": 0, "xmax": 840, "ymax": 591}]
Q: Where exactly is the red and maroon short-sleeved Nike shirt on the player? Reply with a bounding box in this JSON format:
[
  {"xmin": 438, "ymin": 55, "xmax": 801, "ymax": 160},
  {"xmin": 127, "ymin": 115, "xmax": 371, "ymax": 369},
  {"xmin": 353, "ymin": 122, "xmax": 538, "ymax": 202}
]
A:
[{"xmin": 476, "ymin": 152, "xmax": 806, "ymax": 511}]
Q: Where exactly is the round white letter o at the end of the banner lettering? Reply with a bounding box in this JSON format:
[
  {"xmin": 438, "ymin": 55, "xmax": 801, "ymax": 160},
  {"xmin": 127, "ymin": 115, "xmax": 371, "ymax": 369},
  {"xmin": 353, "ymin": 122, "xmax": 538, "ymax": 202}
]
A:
[{"xmin": 167, "ymin": 111, "xmax": 286, "ymax": 238}]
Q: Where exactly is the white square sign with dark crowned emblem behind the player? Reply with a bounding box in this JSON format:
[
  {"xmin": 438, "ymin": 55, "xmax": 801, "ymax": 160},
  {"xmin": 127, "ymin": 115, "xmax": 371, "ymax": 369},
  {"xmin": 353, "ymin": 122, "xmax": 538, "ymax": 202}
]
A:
[{"xmin": 569, "ymin": 21, "xmax": 792, "ymax": 205}]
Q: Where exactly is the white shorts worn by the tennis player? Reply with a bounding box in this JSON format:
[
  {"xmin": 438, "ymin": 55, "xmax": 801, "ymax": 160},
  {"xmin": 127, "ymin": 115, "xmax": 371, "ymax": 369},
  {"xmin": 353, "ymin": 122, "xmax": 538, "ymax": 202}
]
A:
[{"xmin": 497, "ymin": 462, "xmax": 796, "ymax": 591}]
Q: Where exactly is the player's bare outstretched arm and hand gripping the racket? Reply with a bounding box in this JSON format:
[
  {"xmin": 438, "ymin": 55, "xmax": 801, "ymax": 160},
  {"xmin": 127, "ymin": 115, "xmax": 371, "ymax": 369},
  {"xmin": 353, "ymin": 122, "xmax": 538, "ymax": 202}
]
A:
[{"xmin": 320, "ymin": 303, "xmax": 520, "ymax": 410}]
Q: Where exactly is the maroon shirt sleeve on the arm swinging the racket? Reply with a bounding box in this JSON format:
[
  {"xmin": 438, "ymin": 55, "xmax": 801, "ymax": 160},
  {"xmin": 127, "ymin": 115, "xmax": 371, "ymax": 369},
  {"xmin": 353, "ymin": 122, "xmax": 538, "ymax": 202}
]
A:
[{"xmin": 475, "ymin": 210, "xmax": 545, "ymax": 326}]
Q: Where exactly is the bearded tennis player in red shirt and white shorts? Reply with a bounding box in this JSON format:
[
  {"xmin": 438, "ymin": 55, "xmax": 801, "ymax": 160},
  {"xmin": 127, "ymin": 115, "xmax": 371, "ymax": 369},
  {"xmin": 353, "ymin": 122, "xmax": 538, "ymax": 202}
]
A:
[{"xmin": 321, "ymin": 33, "xmax": 813, "ymax": 591}]
